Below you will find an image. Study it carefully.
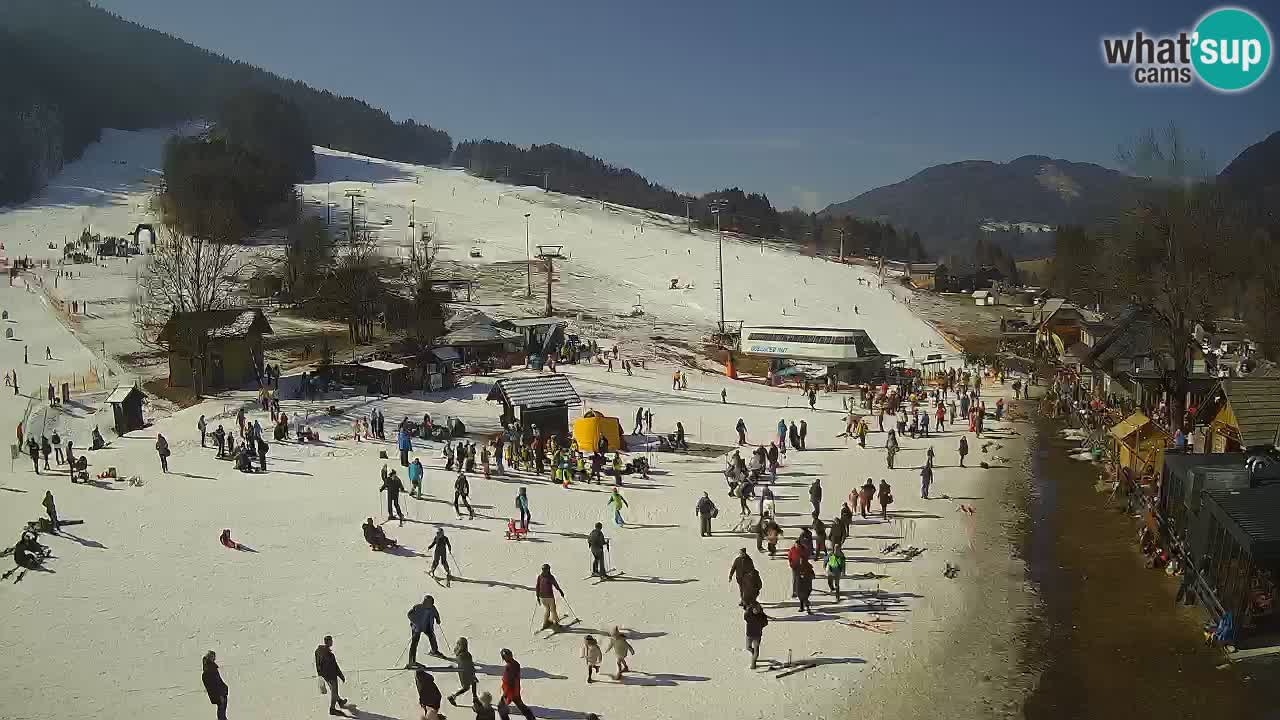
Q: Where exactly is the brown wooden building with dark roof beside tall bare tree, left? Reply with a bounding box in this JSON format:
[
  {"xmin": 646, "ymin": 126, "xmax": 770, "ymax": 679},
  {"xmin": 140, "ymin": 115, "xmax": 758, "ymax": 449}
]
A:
[{"xmin": 160, "ymin": 307, "xmax": 271, "ymax": 389}]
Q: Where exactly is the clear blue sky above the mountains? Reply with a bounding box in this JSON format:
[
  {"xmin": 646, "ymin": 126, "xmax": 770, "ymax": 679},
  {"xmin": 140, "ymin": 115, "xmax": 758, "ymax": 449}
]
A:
[{"xmin": 97, "ymin": 0, "xmax": 1280, "ymax": 209}]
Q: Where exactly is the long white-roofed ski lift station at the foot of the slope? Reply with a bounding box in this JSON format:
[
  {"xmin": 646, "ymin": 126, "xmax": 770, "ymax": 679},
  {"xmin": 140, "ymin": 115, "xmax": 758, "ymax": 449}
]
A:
[{"xmin": 739, "ymin": 325, "xmax": 892, "ymax": 382}]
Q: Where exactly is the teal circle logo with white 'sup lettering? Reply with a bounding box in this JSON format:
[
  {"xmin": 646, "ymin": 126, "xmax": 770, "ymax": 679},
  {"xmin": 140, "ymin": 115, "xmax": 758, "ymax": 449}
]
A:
[{"xmin": 1192, "ymin": 8, "xmax": 1271, "ymax": 92}]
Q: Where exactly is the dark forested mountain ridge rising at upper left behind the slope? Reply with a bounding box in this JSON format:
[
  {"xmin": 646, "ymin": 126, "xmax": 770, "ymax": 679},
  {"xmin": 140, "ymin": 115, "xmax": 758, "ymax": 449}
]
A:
[{"xmin": 0, "ymin": 0, "xmax": 452, "ymax": 202}]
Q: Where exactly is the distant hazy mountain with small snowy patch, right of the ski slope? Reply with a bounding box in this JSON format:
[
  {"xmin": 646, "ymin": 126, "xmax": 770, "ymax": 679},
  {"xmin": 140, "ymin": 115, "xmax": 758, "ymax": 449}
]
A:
[{"xmin": 823, "ymin": 155, "xmax": 1140, "ymax": 252}]
